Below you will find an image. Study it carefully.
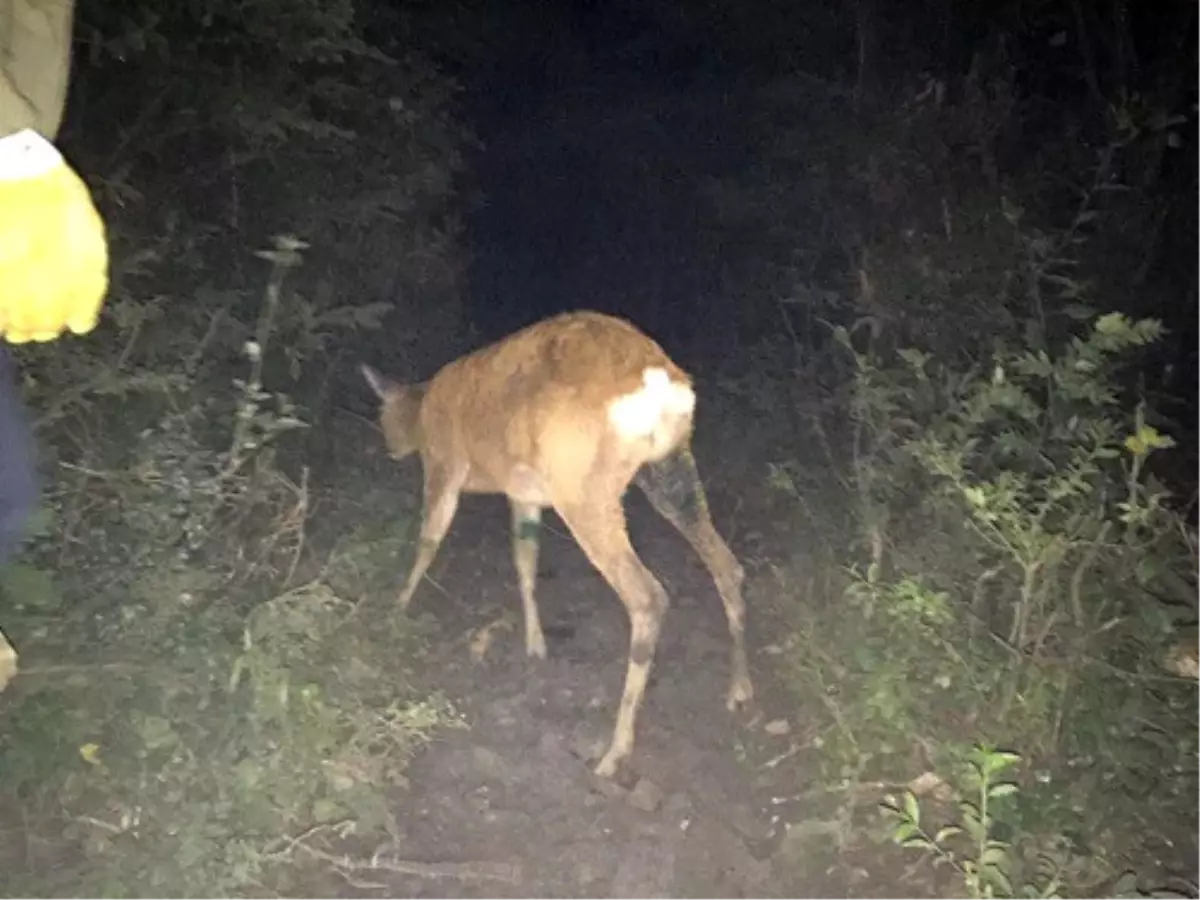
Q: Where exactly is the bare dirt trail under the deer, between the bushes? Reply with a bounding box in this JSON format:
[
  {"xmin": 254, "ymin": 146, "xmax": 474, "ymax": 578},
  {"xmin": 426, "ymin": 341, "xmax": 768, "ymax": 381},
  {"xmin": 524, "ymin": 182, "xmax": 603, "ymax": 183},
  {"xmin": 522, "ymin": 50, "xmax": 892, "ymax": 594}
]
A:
[{"xmin": 324, "ymin": 446, "xmax": 912, "ymax": 900}]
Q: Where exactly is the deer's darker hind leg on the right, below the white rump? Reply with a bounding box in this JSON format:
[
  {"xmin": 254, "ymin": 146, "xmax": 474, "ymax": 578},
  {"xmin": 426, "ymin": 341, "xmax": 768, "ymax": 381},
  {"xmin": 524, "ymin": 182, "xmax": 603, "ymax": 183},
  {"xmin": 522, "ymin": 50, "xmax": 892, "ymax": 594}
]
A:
[{"xmin": 635, "ymin": 446, "xmax": 754, "ymax": 710}]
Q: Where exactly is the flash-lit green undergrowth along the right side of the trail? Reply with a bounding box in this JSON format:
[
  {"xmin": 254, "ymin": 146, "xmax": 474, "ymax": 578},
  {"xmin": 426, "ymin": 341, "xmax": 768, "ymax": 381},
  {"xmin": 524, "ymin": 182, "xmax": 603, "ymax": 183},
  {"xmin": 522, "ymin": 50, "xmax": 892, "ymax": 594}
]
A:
[{"xmin": 736, "ymin": 75, "xmax": 1200, "ymax": 898}]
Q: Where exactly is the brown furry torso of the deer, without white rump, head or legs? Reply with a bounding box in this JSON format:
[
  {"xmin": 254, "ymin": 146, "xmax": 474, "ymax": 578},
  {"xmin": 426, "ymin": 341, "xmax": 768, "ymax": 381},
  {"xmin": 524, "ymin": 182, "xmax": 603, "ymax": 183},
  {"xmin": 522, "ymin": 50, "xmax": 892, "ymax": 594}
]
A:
[{"xmin": 421, "ymin": 312, "xmax": 691, "ymax": 504}]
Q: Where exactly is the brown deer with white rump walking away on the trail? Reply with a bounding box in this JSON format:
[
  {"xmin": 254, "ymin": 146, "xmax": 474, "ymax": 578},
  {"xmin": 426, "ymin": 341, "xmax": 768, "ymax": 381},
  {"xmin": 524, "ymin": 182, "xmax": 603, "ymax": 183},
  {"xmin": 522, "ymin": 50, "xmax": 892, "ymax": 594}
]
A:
[{"xmin": 362, "ymin": 311, "xmax": 754, "ymax": 778}]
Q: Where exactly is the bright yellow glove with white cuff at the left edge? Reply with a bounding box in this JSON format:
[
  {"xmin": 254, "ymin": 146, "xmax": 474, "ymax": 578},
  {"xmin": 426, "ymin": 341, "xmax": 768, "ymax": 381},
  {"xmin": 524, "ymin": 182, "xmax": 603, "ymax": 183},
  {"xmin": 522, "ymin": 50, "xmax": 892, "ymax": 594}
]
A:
[{"xmin": 0, "ymin": 130, "xmax": 108, "ymax": 343}]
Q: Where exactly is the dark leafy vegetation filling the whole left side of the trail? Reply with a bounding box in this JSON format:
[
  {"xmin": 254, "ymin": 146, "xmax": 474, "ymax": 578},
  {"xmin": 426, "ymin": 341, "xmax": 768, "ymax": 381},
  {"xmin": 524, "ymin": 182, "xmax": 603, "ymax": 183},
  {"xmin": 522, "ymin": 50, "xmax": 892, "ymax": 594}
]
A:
[{"xmin": 0, "ymin": 0, "xmax": 469, "ymax": 900}]
